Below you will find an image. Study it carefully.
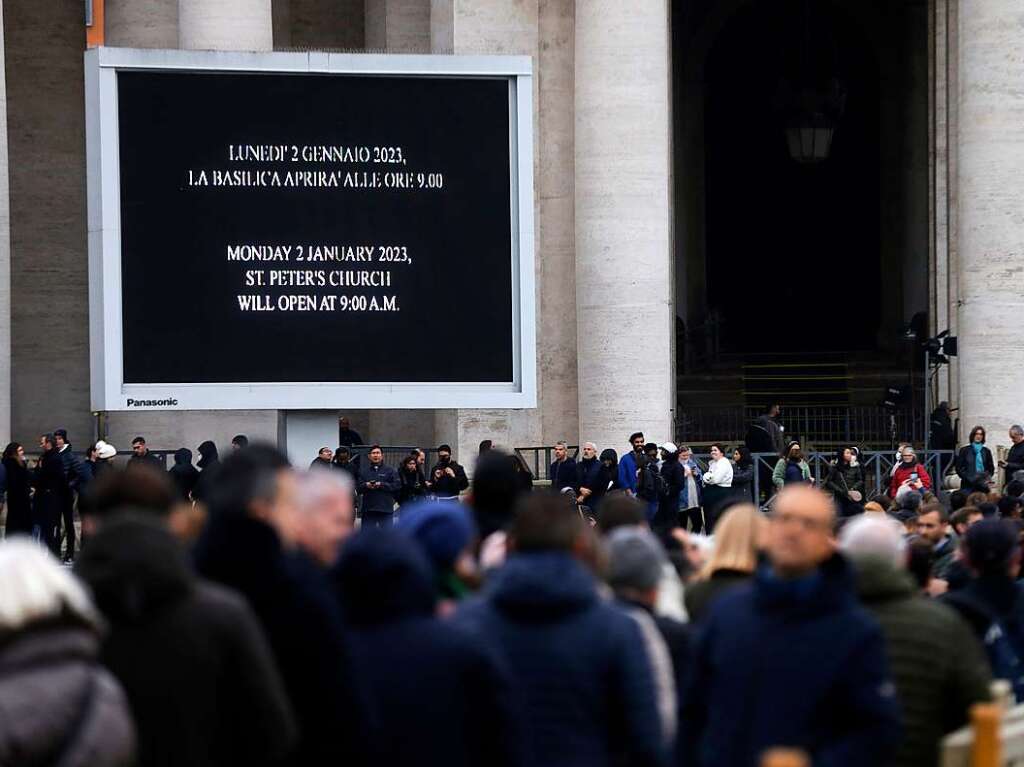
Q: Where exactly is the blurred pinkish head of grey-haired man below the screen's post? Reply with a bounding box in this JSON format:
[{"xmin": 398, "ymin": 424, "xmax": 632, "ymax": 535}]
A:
[{"xmin": 296, "ymin": 469, "xmax": 355, "ymax": 567}]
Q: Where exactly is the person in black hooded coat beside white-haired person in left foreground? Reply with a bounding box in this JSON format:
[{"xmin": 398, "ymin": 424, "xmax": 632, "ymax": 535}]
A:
[{"xmin": 75, "ymin": 509, "xmax": 298, "ymax": 767}]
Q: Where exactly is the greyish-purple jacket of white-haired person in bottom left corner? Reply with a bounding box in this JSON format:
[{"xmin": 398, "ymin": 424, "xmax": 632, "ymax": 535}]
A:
[{"xmin": 0, "ymin": 623, "xmax": 135, "ymax": 767}]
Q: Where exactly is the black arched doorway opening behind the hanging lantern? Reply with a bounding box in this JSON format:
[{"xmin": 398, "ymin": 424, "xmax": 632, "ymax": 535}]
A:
[{"xmin": 705, "ymin": 0, "xmax": 882, "ymax": 352}]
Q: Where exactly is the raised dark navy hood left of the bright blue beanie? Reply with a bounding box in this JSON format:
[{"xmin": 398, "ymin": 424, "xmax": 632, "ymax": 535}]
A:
[{"xmin": 331, "ymin": 528, "xmax": 436, "ymax": 627}]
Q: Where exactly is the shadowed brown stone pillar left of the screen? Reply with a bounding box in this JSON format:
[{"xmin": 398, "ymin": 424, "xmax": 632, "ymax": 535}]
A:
[{"xmin": 3, "ymin": 0, "xmax": 93, "ymax": 448}]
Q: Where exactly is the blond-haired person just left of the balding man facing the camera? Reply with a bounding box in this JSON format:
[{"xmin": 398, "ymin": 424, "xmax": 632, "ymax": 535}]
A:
[{"xmin": 686, "ymin": 504, "xmax": 766, "ymax": 622}]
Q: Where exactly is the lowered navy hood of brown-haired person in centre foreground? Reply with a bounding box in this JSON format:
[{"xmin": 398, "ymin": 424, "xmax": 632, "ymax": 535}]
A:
[{"xmin": 487, "ymin": 551, "xmax": 597, "ymax": 623}]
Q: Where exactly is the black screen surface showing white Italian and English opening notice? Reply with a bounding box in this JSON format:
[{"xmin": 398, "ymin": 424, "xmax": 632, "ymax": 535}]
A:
[{"xmin": 118, "ymin": 72, "xmax": 513, "ymax": 384}]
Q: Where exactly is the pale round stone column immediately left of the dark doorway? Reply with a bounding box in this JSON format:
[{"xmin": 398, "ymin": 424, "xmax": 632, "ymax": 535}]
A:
[{"xmin": 575, "ymin": 0, "xmax": 675, "ymax": 449}]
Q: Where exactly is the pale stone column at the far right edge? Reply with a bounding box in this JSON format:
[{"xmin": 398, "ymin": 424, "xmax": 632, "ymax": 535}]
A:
[{"xmin": 957, "ymin": 0, "xmax": 1024, "ymax": 445}]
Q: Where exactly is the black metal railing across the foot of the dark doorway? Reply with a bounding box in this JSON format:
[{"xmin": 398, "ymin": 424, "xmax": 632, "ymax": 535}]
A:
[{"xmin": 676, "ymin": 404, "xmax": 925, "ymax": 448}]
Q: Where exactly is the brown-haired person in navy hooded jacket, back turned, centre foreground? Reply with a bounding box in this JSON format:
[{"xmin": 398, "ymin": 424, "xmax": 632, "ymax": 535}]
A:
[{"xmin": 456, "ymin": 494, "xmax": 666, "ymax": 767}]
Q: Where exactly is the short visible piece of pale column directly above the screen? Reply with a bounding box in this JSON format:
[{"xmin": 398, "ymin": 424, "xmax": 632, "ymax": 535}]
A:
[{"xmin": 178, "ymin": 0, "xmax": 273, "ymax": 50}]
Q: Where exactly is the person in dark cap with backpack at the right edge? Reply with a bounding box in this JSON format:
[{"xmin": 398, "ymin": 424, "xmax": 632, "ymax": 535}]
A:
[{"xmin": 941, "ymin": 519, "xmax": 1024, "ymax": 700}]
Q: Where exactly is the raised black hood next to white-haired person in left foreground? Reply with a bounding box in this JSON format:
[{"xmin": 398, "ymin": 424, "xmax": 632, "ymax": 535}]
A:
[{"xmin": 75, "ymin": 512, "xmax": 194, "ymax": 624}]
